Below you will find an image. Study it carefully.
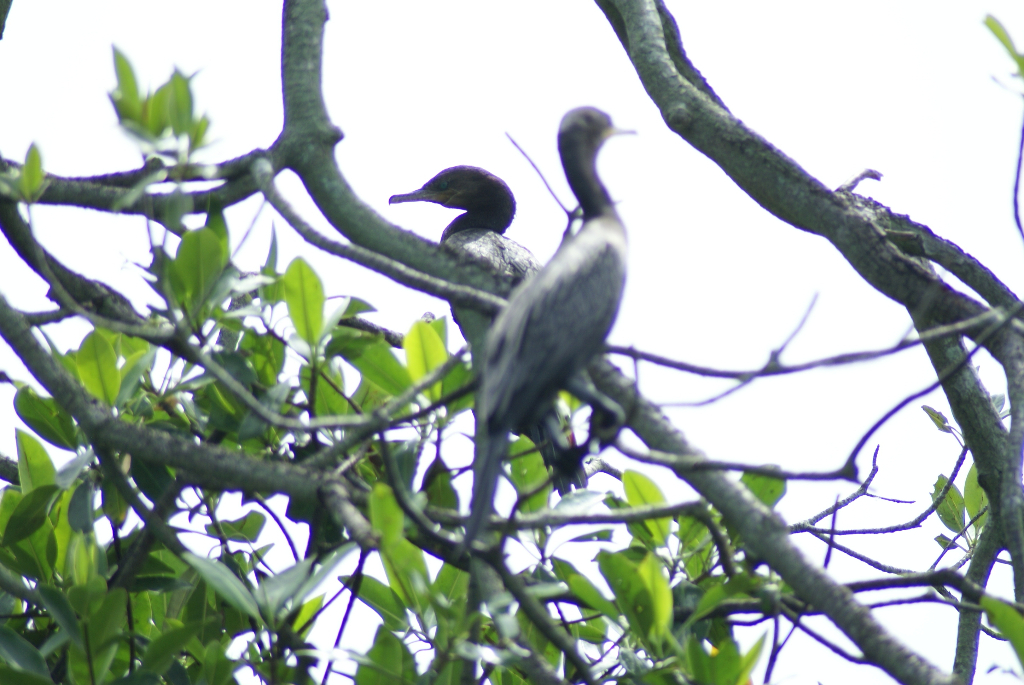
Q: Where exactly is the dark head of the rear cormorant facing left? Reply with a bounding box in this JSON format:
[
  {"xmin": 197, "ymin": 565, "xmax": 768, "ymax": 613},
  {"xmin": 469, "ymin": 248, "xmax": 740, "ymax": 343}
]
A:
[{"xmin": 388, "ymin": 166, "xmax": 515, "ymax": 232}]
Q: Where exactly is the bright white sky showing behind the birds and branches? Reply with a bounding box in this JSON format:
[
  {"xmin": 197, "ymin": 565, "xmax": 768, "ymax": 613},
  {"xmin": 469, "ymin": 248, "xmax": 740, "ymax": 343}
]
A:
[{"xmin": 0, "ymin": 0, "xmax": 1024, "ymax": 684}]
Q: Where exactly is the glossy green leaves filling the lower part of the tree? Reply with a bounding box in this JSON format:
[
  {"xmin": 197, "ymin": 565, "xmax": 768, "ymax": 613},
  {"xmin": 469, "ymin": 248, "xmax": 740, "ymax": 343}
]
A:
[{"xmin": 0, "ymin": 5, "xmax": 1024, "ymax": 685}]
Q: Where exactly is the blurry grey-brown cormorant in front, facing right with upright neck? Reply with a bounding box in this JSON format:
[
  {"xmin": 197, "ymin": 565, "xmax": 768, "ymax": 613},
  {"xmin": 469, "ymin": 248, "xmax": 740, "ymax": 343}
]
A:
[{"xmin": 460, "ymin": 108, "xmax": 627, "ymax": 550}]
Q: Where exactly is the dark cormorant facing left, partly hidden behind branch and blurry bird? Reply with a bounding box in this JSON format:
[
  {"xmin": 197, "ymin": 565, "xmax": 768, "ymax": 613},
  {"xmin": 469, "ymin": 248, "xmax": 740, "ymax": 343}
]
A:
[{"xmin": 388, "ymin": 166, "xmax": 587, "ymax": 495}]
